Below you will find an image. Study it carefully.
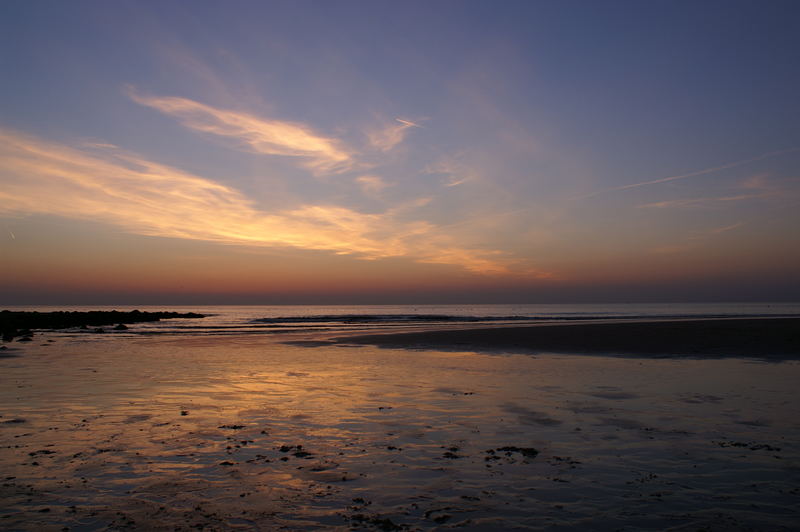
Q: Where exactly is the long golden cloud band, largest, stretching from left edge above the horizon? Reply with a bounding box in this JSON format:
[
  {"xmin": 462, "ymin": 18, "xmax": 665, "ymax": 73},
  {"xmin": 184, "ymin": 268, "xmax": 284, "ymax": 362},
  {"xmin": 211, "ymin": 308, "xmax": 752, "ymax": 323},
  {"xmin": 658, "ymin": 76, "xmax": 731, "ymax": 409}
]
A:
[{"xmin": 0, "ymin": 129, "xmax": 513, "ymax": 273}]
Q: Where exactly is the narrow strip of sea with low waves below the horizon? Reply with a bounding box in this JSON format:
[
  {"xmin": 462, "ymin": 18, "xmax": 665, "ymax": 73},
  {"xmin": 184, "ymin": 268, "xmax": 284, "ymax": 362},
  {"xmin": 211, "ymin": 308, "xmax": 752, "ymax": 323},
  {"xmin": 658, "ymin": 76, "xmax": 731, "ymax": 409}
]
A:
[{"xmin": 4, "ymin": 303, "xmax": 800, "ymax": 335}]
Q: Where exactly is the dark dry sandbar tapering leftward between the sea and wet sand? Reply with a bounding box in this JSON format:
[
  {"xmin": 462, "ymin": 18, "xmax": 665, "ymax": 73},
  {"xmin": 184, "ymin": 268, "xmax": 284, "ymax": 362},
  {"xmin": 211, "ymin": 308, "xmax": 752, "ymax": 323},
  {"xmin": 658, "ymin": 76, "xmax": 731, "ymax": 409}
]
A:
[{"xmin": 337, "ymin": 318, "xmax": 800, "ymax": 359}]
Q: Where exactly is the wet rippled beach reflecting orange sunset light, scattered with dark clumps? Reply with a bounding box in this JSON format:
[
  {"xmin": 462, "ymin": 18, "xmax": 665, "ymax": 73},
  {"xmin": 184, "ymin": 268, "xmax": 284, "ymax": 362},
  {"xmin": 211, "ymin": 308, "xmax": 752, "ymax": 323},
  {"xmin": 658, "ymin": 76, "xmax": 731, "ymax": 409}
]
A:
[{"xmin": 0, "ymin": 310, "xmax": 800, "ymax": 530}]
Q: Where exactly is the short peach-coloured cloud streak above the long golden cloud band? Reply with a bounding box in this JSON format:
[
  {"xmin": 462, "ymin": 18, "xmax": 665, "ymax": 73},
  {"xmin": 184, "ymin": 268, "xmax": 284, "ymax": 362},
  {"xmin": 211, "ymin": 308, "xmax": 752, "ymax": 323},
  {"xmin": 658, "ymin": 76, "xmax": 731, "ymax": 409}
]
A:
[{"xmin": 128, "ymin": 89, "xmax": 354, "ymax": 173}]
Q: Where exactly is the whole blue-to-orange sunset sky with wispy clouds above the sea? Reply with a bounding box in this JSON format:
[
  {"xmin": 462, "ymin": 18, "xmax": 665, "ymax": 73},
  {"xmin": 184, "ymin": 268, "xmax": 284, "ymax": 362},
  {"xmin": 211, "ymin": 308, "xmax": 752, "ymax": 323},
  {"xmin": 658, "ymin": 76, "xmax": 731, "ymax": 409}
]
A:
[{"xmin": 0, "ymin": 0, "xmax": 800, "ymax": 305}]
